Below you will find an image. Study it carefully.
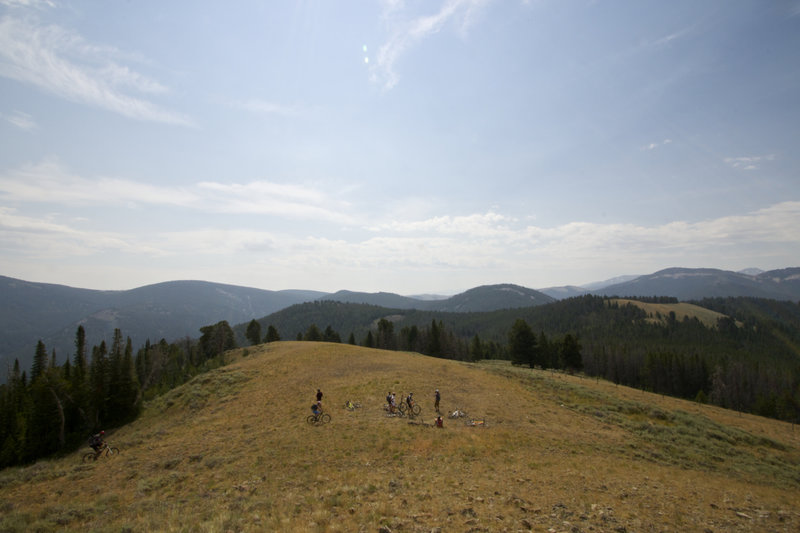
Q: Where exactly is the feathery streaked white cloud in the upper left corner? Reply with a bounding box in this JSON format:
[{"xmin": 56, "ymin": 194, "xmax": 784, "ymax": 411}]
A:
[{"xmin": 0, "ymin": 16, "xmax": 191, "ymax": 125}]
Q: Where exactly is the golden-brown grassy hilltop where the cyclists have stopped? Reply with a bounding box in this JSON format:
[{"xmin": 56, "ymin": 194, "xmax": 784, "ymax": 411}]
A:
[{"xmin": 0, "ymin": 342, "xmax": 800, "ymax": 532}]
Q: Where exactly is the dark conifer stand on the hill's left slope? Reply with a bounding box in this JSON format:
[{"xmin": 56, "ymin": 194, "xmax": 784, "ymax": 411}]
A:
[{"xmin": 0, "ymin": 321, "xmax": 236, "ymax": 468}]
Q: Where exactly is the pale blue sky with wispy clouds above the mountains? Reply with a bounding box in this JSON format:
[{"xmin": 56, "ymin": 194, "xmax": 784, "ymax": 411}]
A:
[{"xmin": 0, "ymin": 0, "xmax": 800, "ymax": 295}]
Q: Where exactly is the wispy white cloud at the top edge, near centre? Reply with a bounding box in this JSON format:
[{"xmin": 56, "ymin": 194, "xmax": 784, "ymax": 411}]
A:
[{"xmin": 372, "ymin": 0, "xmax": 491, "ymax": 89}]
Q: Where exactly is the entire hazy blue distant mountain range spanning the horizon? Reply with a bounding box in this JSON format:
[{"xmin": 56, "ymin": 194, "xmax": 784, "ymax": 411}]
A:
[{"xmin": 0, "ymin": 268, "xmax": 800, "ymax": 382}]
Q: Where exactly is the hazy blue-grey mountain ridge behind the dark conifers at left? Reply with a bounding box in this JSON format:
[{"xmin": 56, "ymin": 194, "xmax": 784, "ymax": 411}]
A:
[{"xmin": 0, "ymin": 276, "xmax": 324, "ymax": 374}]
